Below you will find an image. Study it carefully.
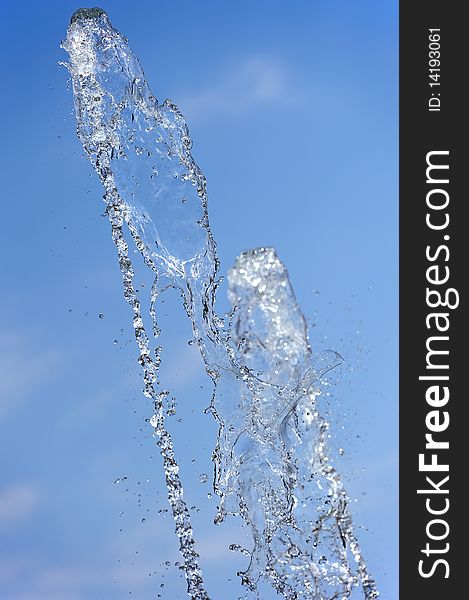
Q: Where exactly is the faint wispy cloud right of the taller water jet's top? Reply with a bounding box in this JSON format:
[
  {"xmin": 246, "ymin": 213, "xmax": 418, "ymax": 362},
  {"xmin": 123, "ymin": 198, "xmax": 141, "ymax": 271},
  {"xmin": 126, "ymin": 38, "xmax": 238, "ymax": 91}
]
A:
[{"xmin": 178, "ymin": 56, "xmax": 301, "ymax": 122}]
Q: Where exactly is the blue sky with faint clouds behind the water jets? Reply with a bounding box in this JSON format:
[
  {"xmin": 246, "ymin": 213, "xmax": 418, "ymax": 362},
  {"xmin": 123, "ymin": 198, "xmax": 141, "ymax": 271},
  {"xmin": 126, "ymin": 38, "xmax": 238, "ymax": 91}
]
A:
[{"xmin": 0, "ymin": 0, "xmax": 398, "ymax": 600}]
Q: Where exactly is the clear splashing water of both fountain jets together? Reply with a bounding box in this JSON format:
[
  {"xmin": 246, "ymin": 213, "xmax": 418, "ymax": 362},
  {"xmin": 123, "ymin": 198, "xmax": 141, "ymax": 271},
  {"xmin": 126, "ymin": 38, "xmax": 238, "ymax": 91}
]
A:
[{"xmin": 63, "ymin": 8, "xmax": 378, "ymax": 600}]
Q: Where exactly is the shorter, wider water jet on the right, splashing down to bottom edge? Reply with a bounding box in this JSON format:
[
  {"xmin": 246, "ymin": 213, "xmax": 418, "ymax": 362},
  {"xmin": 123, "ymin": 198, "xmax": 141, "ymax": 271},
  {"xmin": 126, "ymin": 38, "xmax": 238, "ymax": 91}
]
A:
[{"xmin": 214, "ymin": 248, "xmax": 378, "ymax": 599}]
